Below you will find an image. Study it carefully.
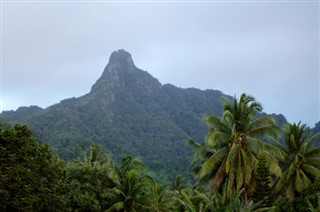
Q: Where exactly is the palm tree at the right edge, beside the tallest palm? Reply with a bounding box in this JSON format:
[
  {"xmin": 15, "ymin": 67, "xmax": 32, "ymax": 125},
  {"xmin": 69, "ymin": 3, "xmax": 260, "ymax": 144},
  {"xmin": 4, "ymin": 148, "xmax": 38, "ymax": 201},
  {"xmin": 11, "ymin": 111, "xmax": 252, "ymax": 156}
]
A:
[{"xmin": 276, "ymin": 122, "xmax": 320, "ymax": 199}]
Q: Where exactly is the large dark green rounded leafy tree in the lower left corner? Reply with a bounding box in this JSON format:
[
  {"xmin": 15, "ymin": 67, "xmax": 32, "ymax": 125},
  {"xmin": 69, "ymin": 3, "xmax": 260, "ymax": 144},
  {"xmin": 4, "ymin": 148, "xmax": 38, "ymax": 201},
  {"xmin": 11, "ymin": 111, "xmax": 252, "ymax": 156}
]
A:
[{"xmin": 0, "ymin": 125, "xmax": 66, "ymax": 211}]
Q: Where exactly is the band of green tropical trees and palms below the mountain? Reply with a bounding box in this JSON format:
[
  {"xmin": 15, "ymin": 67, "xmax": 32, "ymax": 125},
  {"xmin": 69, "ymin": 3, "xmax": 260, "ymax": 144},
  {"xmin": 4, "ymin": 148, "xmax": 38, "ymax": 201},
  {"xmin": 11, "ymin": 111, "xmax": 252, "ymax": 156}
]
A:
[{"xmin": 0, "ymin": 94, "xmax": 320, "ymax": 211}]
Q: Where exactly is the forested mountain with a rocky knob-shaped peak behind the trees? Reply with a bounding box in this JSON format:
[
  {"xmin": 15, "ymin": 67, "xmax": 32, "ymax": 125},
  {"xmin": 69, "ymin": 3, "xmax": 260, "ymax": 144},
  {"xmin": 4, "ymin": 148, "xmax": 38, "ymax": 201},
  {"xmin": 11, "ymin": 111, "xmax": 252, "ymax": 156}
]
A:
[{"xmin": 1, "ymin": 50, "xmax": 286, "ymax": 181}]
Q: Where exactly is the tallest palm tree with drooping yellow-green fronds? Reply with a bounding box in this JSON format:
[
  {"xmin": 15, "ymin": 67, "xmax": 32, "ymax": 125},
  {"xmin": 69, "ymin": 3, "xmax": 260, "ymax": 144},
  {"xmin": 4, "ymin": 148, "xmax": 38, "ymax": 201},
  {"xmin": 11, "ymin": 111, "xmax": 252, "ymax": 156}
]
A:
[{"xmin": 192, "ymin": 94, "xmax": 281, "ymax": 200}]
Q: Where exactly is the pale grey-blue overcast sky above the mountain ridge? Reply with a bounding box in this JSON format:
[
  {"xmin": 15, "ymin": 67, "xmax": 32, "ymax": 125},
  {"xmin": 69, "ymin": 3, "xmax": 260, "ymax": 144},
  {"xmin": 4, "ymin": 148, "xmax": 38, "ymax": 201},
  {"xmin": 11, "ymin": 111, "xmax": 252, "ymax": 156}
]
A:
[{"xmin": 1, "ymin": 0, "xmax": 320, "ymax": 127}]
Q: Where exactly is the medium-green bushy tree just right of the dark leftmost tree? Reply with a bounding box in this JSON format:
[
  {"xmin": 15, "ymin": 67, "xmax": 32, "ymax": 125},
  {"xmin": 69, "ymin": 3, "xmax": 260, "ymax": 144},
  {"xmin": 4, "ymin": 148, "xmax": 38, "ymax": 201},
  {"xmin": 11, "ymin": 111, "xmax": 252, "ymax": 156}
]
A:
[{"xmin": 65, "ymin": 145, "xmax": 119, "ymax": 211}]
